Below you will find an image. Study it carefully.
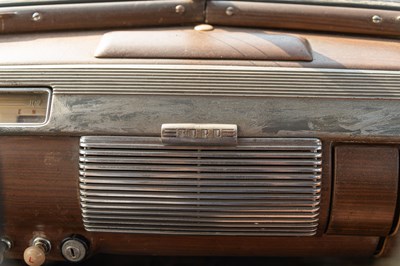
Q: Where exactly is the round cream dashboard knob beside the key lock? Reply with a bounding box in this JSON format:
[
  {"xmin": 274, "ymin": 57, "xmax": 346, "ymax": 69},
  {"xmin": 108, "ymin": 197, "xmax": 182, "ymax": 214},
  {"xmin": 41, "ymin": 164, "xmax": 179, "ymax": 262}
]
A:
[{"xmin": 24, "ymin": 237, "xmax": 51, "ymax": 266}]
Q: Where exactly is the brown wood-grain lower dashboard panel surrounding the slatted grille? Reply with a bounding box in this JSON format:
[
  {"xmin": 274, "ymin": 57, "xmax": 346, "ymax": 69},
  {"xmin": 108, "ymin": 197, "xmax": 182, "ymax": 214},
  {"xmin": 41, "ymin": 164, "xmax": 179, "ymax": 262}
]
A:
[{"xmin": 0, "ymin": 136, "xmax": 394, "ymax": 260}]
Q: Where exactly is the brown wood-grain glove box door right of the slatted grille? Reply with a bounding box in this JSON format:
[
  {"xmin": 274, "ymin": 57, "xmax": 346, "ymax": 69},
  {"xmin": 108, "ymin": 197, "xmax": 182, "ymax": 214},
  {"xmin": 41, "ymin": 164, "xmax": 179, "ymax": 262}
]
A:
[{"xmin": 327, "ymin": 145, "xmax": 399, "ymax": 236}]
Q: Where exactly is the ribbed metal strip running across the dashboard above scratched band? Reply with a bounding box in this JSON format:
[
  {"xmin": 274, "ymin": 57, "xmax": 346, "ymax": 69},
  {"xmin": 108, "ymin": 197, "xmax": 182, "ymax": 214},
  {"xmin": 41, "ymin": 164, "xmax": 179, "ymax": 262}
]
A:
[{"xmin": 0, "ymin": 65, "xmax": 400, "ymax": 99}]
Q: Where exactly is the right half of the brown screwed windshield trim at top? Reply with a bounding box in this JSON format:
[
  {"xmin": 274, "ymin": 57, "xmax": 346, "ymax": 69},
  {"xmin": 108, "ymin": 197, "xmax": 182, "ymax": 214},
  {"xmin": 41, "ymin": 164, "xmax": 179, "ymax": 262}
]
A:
[{"xmin": 206, "ymin": 0, "xmax": 400, "ymax": 36}]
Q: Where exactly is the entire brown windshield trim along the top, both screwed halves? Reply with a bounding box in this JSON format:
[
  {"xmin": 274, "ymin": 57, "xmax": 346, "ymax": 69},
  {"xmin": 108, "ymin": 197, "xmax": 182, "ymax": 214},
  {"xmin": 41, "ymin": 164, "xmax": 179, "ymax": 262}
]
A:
[{"xmin": 0, "ymin": 0, "xmax": 400, "ymax": 36}]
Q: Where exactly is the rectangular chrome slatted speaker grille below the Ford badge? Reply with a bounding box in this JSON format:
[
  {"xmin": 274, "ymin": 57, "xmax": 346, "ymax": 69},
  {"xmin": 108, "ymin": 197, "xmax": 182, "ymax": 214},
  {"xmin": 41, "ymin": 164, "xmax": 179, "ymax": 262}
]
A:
[{"xmin": 80, "ymin": 136, "xmax": 321, "ymax": 236}]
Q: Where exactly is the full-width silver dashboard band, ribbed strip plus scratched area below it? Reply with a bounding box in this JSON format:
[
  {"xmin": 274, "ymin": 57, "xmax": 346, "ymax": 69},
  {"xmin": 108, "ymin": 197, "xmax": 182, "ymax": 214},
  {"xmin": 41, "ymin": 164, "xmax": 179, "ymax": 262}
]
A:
[{"xmin": 0, "ymin": 64, "xmax": 400, "ymax": 137}]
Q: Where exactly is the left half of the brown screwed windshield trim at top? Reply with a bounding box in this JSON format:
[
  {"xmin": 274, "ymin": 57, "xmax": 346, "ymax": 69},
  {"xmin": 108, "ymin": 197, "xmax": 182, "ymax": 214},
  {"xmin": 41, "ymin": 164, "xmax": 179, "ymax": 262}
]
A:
[{"xmin": 0, "ymin": 0, "xmax": 204, "ymax": 33}]
